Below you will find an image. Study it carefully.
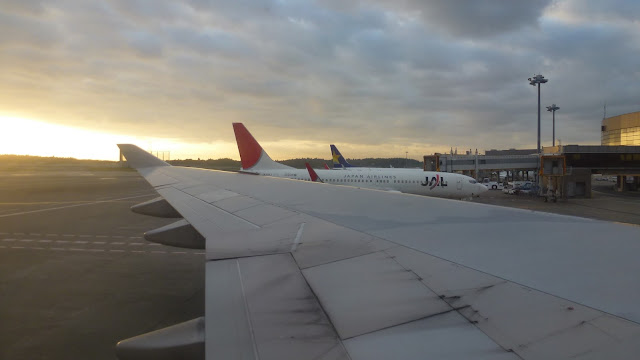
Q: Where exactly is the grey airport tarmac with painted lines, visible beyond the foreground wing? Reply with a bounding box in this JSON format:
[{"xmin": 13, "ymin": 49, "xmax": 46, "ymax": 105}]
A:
[{"xmin": 0, "ymin": 169, "xmax": 640, "ymax": 360}]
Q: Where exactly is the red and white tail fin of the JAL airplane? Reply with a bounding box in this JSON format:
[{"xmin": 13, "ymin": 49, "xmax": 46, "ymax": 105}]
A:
[{"xmin": 233, "ymin": 123, "xmax": 292, "ymax": 170}]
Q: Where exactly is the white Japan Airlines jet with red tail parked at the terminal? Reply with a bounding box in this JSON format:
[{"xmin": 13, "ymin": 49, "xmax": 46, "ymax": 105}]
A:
[{"xmin": 233, "ymin": 123, "xmax": 487, "ymax": 199}]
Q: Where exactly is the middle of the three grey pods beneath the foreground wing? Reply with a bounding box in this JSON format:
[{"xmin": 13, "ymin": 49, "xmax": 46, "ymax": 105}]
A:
[{"xmin": 144, "ymin": 219, "xmax": 206, "ymax": 249}]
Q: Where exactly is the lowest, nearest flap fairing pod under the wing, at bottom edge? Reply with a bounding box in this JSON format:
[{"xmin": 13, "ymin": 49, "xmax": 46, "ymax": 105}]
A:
[{"xmin": 116, "ymin": 317, "xmax": 204, "ymax": 360}]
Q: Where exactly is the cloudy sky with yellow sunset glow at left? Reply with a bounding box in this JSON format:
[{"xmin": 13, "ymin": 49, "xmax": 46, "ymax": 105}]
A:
[{"xmin": 0, "ymin": 0, "xmax": 640, "ymax": 159}]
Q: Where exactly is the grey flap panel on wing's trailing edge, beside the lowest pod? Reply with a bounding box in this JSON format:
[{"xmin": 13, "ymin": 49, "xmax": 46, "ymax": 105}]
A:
[{"xmin": 205, "ymin": 254, "xmax": 348, "ymax": 359}]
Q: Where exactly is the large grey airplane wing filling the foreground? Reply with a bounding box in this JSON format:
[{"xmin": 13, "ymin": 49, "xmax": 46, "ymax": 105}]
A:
[{"xmin": 118, "ymin": 145, "xmax": 640, "ymax": 360}]
